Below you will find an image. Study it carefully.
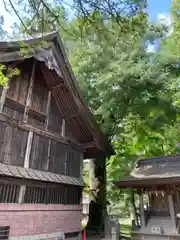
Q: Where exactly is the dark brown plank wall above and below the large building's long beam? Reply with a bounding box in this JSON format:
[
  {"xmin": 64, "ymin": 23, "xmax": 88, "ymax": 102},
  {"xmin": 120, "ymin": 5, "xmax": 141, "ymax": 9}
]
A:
[{"xmin": 0, "ymin": 59, "xmax": 82, "ymax": 177}]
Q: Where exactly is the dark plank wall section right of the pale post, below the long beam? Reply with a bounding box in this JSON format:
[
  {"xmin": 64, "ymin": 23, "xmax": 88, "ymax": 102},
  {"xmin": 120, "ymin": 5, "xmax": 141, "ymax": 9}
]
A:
[{"xmin": 30, "ymin": 134, "xmax": 81, "ymax": 177}]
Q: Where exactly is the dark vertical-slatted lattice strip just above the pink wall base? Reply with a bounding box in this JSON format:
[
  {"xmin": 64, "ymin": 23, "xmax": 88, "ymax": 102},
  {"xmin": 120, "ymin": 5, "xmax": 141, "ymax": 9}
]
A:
[{"xmin": 0, "ymin": 179, "xmax": 82, "ymax": 205}]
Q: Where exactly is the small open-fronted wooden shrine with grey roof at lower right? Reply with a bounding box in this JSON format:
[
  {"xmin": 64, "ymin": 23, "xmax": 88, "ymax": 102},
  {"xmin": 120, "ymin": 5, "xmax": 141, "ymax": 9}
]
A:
[{"xmin": 115, "ymin": 155, "xmax": 180, "ymax": 240}]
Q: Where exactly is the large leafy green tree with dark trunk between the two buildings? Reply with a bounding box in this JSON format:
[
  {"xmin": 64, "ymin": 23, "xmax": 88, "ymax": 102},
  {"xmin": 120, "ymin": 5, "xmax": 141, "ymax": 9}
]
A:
[{"xmin": 13, "ymin": 0, "xmax": 178, "ymax": 234}]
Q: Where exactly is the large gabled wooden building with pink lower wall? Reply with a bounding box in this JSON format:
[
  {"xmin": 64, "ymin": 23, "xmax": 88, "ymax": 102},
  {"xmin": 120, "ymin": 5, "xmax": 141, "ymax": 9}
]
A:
[{"xmin": 0, "ymin": 32, "xmax": 112, "ymax": 240}]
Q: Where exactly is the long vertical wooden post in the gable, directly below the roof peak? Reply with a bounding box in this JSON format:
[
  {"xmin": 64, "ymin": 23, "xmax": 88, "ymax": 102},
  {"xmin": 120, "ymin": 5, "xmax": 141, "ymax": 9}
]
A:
[{"xmin": 23, "ymin": 60, "xmax": 36, "ymax": 122}]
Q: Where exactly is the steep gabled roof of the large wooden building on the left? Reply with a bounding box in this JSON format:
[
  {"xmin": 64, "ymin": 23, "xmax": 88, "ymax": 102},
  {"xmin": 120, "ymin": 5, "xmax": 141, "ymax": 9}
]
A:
[{"xmin": 0, "ymin": 32, "xmax": 114, "ymax": 158}]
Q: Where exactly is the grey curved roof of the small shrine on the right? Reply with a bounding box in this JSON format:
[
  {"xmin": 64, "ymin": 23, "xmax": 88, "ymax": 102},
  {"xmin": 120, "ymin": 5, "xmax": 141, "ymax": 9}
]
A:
[{"xmin": 114, "ymin": 155, "xmax": 180, "ymax": 188}]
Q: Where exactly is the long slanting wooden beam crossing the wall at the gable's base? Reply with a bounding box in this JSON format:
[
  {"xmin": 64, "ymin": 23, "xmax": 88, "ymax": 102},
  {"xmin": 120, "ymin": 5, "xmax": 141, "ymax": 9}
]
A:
[{"xmin": 0, "ymin": 113, "xmax": 84, "ymax": 151}]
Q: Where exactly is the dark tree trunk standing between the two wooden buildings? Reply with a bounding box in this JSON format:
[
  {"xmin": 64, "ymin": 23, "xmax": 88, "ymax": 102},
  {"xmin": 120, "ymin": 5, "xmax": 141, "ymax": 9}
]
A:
[{"xmin": 87, "ymin": 156, "xmax": 107, "ymax": 235}]
